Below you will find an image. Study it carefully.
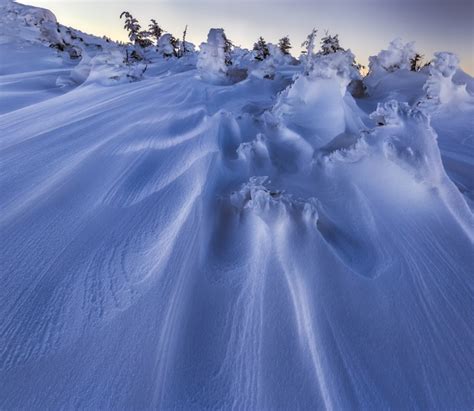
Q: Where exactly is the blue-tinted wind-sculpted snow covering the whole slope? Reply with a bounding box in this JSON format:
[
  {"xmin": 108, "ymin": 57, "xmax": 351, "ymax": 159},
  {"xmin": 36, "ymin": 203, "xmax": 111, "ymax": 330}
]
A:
[{"xmin": 0, "ymin": 0, "xmax": 474, "ymax": 410}]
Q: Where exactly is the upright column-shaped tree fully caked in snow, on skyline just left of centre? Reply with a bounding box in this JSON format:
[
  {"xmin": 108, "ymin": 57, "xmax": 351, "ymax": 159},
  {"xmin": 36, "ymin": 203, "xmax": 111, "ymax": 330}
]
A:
[{"xmin": 197, "ymin": 29, "xmax": 232, "ymax": 82}]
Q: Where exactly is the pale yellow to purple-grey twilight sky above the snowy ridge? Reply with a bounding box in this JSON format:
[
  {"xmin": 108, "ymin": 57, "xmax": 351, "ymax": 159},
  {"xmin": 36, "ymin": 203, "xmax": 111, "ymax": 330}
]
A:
[{"xmin": 27, "ymin": 0, "xmax": 474, "ymax": 75}]
